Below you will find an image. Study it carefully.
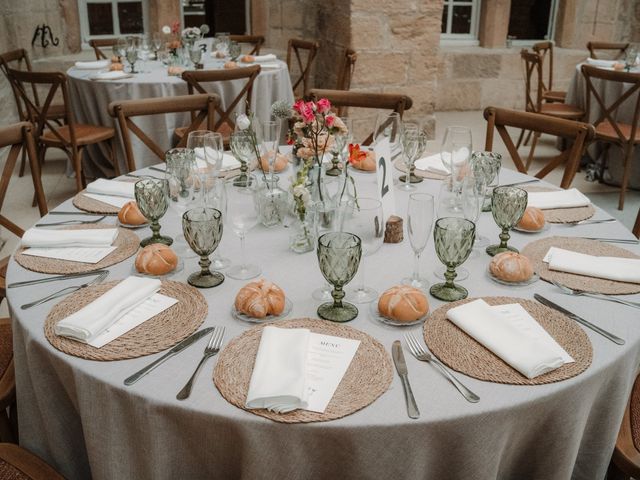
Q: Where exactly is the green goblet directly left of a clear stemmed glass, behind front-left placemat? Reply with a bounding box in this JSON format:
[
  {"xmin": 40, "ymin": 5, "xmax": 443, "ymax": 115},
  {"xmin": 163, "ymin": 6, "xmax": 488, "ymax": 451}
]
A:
[{"xmin": 182, "ymin": 208, "xmax": 224, "ymax": 288}]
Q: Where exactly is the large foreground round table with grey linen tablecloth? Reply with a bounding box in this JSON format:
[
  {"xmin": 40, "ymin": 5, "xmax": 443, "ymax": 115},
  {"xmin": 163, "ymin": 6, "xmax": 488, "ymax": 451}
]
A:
[{"xmin": 7, "ymin": 158, "xmax": 640, "ymax": 480}]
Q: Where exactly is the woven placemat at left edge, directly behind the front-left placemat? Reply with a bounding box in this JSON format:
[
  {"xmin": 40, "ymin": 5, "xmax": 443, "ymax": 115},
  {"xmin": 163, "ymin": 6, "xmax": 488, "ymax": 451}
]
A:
[{"xmin": 15, "ymin": 225, "xmax": 140, "ymax": 275}]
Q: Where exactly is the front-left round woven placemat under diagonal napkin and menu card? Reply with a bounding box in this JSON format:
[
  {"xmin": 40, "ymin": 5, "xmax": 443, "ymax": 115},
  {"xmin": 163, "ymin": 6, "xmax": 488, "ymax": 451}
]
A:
[{"xmin": 44, "ymin": 280, "xmax": 208, "ymax": 362}]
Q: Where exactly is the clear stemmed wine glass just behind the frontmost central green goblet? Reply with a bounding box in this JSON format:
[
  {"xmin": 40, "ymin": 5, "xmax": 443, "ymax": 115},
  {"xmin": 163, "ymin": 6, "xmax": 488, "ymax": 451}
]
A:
[{"xmin": 344, "ymin": 198, "xmax": 384, "ymax": 303}]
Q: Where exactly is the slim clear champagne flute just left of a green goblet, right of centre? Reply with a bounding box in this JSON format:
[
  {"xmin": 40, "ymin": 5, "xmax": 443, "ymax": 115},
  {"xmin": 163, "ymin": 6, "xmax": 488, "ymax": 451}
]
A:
[{"xmin": 402, "ymin": 193, "xmax": 434, "ymax": 291}]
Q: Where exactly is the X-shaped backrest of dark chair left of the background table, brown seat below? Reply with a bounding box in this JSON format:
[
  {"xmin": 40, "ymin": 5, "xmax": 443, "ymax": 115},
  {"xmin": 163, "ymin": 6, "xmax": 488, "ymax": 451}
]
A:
[{"xmin": 8, "ymin": 68, "xmax": 76, "ymax": 144}]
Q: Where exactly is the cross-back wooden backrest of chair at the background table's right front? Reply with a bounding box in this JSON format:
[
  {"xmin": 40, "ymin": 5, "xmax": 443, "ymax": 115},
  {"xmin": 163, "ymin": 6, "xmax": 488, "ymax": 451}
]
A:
[{"xmin": 182, "ymin": 65, "xmax": 260, "ymax": 131}]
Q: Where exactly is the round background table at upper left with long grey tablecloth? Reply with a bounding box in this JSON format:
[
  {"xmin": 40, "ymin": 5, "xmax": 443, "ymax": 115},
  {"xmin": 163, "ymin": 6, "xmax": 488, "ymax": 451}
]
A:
[{"xmin": 67, "ymin": 56, "xmax": 294, "ymax": 177}]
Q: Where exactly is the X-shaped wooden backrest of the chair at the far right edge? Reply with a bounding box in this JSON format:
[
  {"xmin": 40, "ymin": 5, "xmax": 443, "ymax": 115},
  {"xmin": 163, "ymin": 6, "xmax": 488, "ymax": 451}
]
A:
[{"xmin": 581, "ymin": 65, "xmax": 640, "ymax": 145}]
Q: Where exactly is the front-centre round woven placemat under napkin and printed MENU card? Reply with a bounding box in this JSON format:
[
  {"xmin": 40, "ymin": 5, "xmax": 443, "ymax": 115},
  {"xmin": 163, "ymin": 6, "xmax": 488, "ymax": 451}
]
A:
[{"xmin": 213, "ymin": 318, "xmax": 393, "ymax": 423}]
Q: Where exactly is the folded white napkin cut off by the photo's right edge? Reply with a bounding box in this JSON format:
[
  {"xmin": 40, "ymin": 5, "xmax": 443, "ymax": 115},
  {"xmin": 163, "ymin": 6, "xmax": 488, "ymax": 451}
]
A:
[{"xmin": 543, "ymin": 247, "xmax": 640, "ymax": 283}]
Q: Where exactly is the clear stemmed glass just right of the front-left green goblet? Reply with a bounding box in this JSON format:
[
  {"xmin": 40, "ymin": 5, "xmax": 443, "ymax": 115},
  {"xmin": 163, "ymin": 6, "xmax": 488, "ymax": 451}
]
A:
[{"xmin": 225, "ymin": 175, "xmax": 262, "ymax": 280}]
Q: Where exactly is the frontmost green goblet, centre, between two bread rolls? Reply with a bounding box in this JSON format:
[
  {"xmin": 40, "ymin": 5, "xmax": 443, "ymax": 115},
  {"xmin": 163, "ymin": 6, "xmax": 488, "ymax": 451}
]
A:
[{"xmin": 318, "ymin": 232, "xmax": 362, "ymax": 322}]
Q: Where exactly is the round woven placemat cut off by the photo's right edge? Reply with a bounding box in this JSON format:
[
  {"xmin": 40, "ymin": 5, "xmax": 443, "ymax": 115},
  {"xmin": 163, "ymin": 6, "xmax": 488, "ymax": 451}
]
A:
[{"xmin": 520, "ymin": 237, "xmax": 640, "ymax": 295}]
